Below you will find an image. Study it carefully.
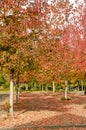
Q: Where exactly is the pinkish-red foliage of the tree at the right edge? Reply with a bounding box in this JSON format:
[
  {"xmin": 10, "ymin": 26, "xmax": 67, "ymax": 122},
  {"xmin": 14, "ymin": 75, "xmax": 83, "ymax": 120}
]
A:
[{"xmin": 62, "ymin": 3, "xmax": 86, "ymax": 97}]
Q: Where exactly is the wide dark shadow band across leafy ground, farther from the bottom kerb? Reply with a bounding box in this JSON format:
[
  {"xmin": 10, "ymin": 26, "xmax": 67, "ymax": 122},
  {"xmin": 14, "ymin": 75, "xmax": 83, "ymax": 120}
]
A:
[{"xmin": 14, "ymin": 93, "xmax": 86, "ymax": 112}]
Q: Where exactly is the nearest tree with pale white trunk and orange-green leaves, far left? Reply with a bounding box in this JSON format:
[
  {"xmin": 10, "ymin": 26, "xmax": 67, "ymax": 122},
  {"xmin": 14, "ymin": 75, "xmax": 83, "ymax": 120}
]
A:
[{"xmin": 0, "ymin": 0, "xmax": 41, "ymax": 115}]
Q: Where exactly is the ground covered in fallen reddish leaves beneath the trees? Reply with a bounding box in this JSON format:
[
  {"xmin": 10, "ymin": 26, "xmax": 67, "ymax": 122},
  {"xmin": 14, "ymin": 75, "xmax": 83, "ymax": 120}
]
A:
[{"xmin": 0, "ymin": 92, "xmax": 86, "ymax": 130}]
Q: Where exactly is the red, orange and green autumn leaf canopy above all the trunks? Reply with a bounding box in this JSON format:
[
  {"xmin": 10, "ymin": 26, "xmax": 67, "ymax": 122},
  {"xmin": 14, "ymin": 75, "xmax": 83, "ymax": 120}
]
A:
[{"xmin": 0, "ymin": 0, "xmax": 86, "ymax": 82}]
